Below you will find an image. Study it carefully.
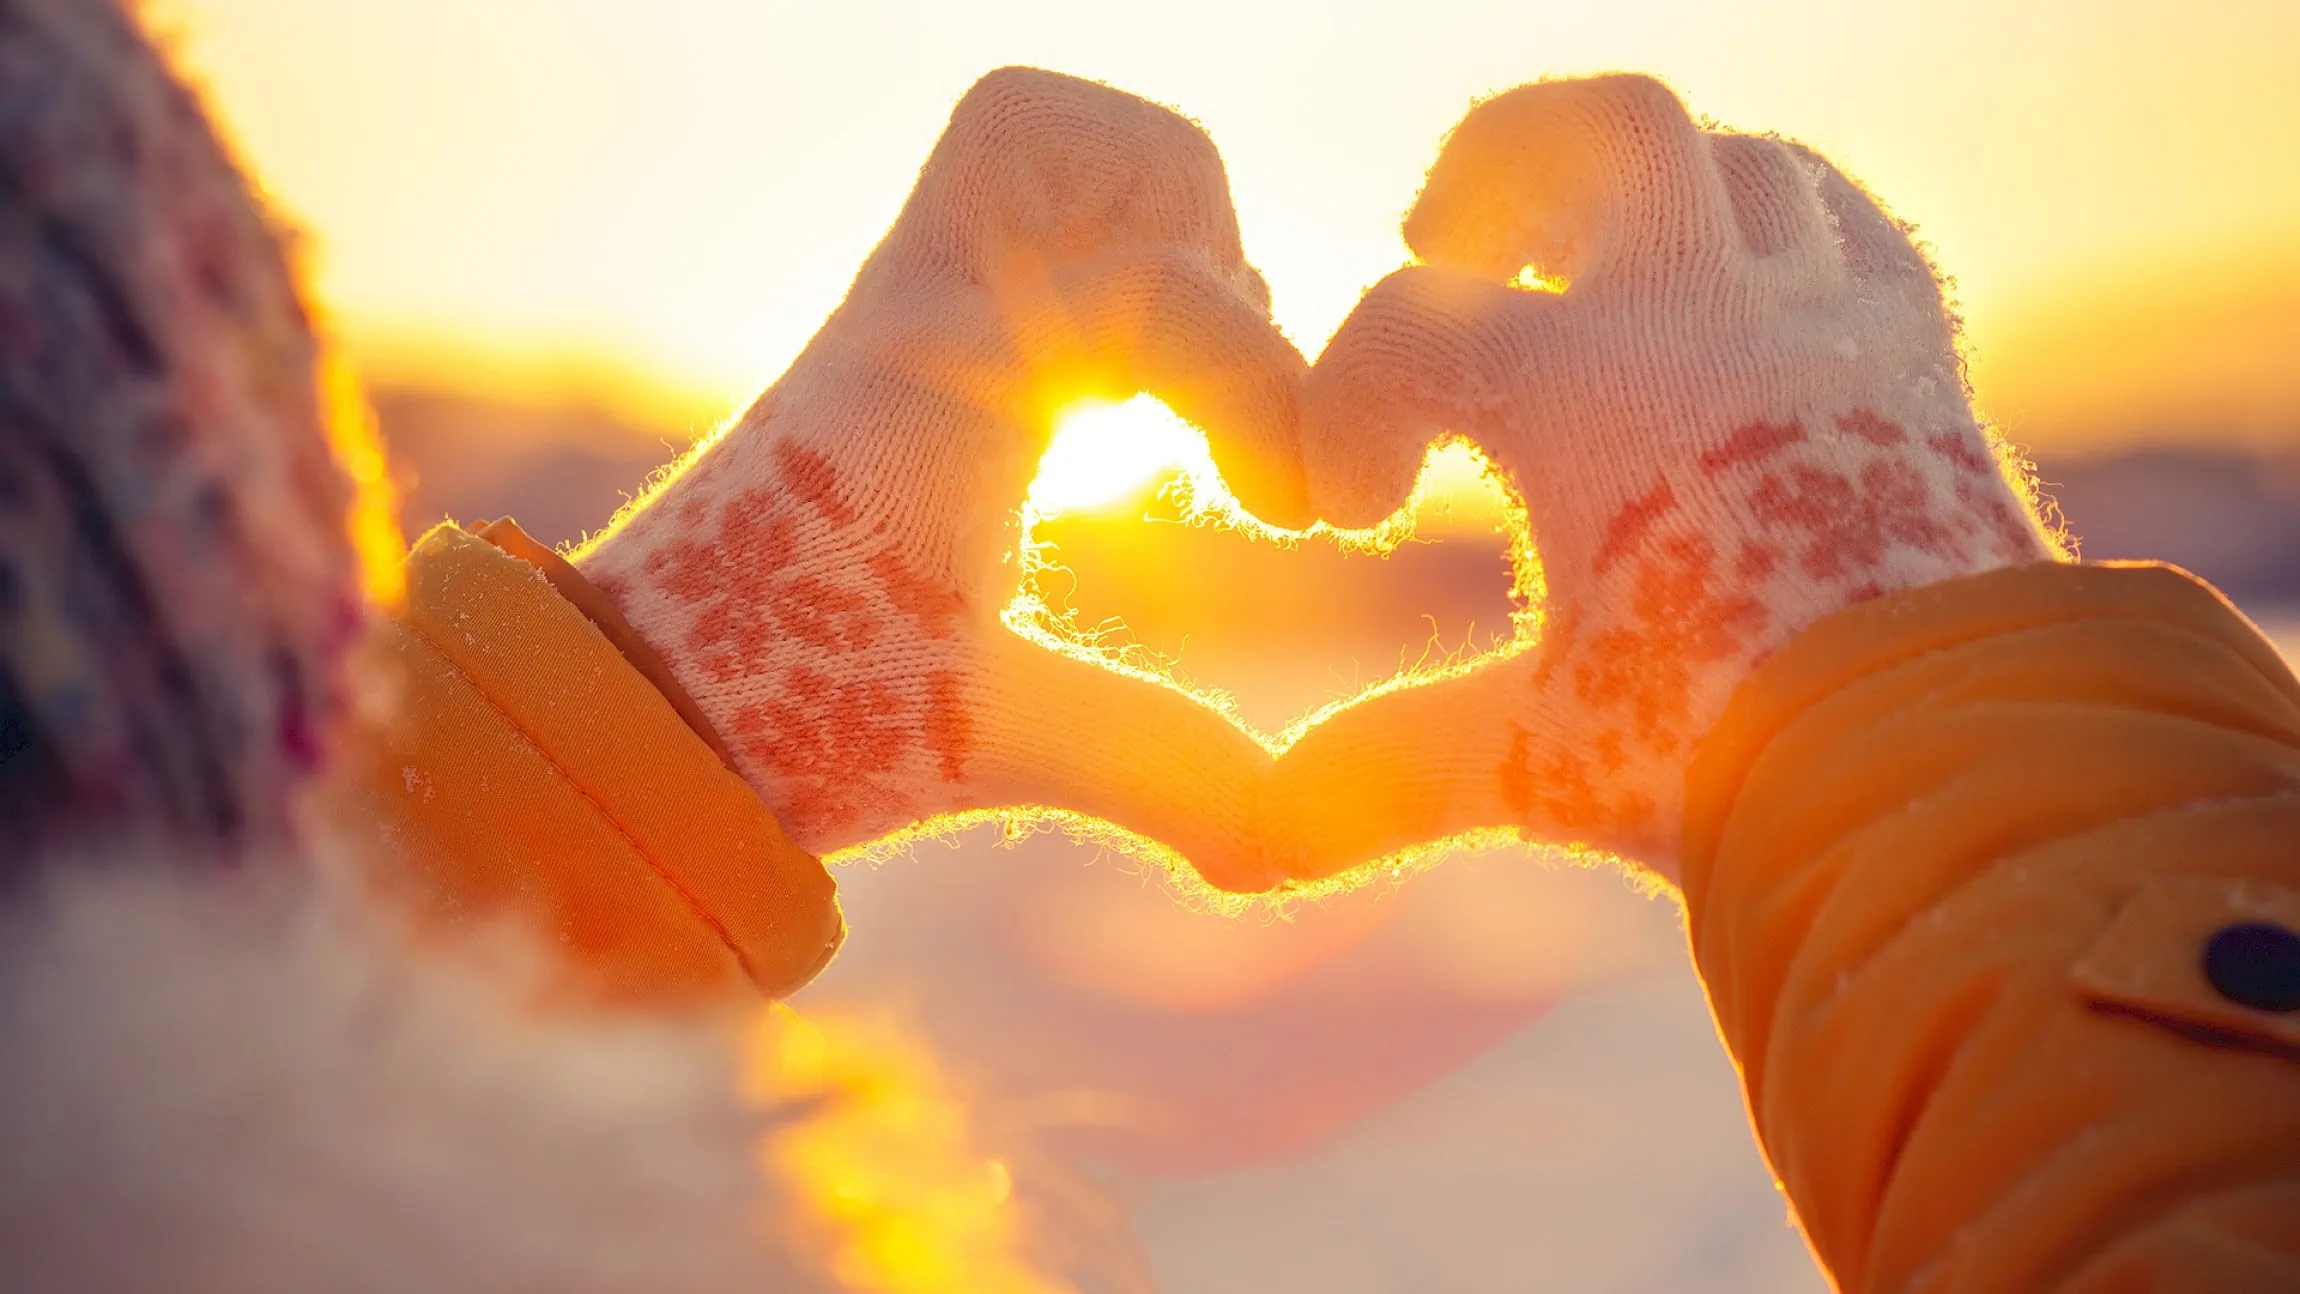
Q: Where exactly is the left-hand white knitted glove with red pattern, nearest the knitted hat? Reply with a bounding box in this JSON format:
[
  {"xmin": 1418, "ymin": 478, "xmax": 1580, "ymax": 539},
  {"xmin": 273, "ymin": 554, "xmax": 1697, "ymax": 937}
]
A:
[{"xmin": 575, "ymin": 69, "xmax": 1304, "ymax": 871}]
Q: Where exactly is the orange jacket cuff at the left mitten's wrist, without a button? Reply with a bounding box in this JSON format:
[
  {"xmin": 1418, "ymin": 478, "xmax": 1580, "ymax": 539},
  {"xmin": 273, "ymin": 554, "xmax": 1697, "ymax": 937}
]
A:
[{"xmin": 329, "ymin": 526, "xmax": 844, "ymax": 1002}]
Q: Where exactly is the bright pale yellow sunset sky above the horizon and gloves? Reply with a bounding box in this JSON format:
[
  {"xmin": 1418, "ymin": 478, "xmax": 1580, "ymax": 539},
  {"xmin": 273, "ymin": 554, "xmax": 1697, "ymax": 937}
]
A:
[{"xmin": 147, "ymin": 0, "xmax": 2300, "ymax": 448}]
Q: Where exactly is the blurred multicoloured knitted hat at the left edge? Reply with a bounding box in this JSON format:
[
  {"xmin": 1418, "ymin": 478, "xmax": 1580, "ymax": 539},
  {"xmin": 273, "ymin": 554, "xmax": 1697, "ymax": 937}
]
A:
[{"xmin": 0, "ymin": 0, "xmax": 359, "ymax": 864}]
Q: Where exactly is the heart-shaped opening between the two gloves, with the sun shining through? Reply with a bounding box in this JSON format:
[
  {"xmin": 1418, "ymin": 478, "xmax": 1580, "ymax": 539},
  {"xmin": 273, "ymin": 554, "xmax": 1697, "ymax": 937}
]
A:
[{"xmin": 1003, "ymin": 395, "xmax": 1539, "ymax": 756}]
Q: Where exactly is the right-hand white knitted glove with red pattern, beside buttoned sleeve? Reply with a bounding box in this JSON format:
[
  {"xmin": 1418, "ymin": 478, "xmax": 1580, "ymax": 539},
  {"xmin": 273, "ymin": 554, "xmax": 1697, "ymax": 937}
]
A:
[{"xmin": 1267, "ymin": 76, "xmax": 2056, "ymax": 876}]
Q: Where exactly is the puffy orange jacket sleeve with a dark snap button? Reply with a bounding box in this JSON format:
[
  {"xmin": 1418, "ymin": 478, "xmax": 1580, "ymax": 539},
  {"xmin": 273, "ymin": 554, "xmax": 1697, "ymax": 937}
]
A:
[{"xmin": 1684, "ymin": 565, "xmax": 2300, "ymax": 1294}]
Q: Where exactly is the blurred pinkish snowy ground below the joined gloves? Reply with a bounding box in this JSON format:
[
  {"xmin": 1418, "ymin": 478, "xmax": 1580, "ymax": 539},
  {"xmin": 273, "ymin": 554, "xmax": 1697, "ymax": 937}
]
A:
[{"xmin": 818, "ymin": 839, "xmax": 1824, "ymax": 1294}]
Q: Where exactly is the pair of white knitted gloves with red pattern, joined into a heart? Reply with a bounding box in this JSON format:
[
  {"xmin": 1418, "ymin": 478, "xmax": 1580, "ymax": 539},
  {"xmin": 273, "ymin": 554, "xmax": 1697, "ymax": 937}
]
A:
[{"xmin": 577, "ymin": 69, "xmax": 2049, "ymax": 892}]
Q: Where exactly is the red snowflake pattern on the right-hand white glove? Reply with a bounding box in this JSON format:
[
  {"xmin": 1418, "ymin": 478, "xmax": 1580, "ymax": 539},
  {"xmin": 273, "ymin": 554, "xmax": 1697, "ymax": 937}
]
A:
[{"xmin": 1500, "ymin": 409, "xmax": 2036, "ymax": 839}]
